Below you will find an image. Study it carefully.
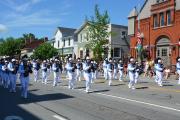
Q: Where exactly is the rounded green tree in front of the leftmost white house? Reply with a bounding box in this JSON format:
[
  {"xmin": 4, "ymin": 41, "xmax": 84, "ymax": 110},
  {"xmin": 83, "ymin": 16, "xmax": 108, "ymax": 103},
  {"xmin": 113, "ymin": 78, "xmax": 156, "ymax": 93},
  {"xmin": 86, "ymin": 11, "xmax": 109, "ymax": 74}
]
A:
[{"xmin": 32, "ymin": 43, "xmax": 58, "ymax": 60}]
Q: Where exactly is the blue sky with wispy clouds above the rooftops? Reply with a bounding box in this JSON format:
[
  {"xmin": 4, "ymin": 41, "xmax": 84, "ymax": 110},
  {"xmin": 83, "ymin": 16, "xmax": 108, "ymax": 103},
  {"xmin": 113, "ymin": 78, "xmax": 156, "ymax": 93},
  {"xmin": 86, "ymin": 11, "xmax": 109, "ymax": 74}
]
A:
[{"xmin": 0, "ymin": 0, "xmax": 144, "ymax": 39}]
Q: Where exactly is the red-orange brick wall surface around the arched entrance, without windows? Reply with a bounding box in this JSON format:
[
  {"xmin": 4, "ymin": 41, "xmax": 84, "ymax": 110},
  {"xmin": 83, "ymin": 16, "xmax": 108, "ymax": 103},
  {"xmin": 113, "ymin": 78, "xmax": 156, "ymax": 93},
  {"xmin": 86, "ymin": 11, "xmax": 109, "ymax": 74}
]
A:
[{"xmin": 130, "ymin": 3, "xmax": 180, "ymax": 64}]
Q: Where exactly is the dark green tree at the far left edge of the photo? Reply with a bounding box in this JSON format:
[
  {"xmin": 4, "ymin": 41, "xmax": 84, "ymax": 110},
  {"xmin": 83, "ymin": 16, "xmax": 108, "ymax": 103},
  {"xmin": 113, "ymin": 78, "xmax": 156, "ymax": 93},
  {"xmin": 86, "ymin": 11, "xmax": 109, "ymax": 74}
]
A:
[{"xmin": 0, "ymin": 37, "xmax": 23, "ymax": 57}]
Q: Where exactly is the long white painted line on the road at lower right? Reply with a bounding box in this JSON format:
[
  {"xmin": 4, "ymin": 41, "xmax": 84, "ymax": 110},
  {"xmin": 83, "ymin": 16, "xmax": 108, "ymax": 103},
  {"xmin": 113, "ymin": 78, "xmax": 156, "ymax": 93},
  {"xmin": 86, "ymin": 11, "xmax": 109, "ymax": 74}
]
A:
[{"xmin": 96, "ymin": 93, "xmax": 180, "ymax": 112}]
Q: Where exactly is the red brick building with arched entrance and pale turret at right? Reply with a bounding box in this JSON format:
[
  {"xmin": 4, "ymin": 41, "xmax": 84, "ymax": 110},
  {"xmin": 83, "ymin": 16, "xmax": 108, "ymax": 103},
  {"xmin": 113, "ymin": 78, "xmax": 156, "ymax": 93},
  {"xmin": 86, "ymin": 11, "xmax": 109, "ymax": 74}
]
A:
[{"xmin": 128, "ymin": 0, "xmax": 180, "ymax": 65}]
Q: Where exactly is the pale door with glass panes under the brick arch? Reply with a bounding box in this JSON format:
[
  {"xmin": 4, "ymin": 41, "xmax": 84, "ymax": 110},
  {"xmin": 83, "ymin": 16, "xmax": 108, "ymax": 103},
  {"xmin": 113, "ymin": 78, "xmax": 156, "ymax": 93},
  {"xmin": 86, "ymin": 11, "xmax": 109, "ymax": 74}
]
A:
[{"xmin": 156, "ymin": 46, "xmax": 170, "ymax": 66}]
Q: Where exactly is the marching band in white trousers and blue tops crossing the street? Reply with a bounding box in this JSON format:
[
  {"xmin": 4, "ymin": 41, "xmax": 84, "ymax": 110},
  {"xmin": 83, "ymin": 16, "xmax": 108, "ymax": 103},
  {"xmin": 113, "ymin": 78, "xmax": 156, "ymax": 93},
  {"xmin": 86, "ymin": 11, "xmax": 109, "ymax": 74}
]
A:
[{"xmin": 0, "ymin": 56, "xmax": 180, "ymax": 98}]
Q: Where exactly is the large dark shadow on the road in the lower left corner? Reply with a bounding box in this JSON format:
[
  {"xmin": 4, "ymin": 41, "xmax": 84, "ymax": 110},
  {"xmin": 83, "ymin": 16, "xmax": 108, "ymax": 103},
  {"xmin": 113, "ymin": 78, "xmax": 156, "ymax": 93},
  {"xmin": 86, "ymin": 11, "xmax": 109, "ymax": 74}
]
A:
[{"xmin": 0, "ymin": 86, "xmax": 73, "ymax": 120}]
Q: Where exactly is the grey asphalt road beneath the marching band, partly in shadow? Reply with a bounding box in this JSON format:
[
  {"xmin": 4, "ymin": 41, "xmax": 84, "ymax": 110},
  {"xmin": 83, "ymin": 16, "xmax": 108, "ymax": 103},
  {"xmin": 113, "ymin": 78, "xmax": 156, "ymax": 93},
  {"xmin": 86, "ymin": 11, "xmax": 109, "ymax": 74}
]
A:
[{"xmin": 0, "ymin": 73, "xmax": 180, "ymax": 120}]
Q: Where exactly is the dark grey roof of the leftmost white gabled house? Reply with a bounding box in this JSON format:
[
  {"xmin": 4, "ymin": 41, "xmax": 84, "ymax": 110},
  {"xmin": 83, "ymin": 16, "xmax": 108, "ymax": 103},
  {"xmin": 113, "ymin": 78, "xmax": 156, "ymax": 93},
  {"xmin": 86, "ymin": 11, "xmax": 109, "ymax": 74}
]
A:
[{"xmin": 55, "ymin": 27, "xmax": 76, "ymax": 37}]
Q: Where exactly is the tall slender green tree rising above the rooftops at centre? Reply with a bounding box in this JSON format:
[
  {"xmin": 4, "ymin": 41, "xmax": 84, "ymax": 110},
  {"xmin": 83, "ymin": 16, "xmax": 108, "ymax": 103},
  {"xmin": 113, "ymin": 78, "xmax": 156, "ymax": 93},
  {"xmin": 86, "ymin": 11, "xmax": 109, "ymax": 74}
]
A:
[{"xmin": 86, "ymin": 5, "xmax": 111, "ymax": 60}]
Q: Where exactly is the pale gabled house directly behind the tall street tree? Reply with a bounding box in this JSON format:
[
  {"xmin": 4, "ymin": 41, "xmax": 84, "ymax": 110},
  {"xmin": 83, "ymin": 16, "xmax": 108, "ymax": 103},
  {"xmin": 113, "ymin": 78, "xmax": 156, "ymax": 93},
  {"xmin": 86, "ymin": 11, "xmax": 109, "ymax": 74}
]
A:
[{"xmin": 75, "ymin": 22, "xmax": 130, "ymax": 59}]
